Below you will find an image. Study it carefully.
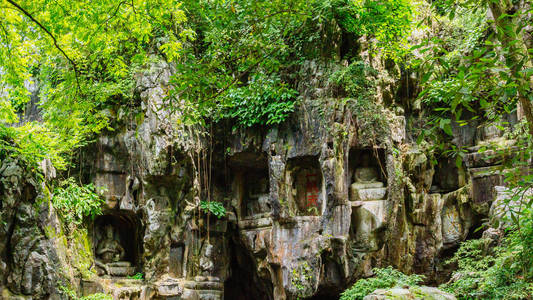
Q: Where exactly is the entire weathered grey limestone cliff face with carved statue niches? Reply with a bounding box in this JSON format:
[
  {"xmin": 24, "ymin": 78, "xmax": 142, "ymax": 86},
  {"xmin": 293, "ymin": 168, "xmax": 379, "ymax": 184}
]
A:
[{"xmin": 0, "ymin": 62, "xmax": 512, "ymax": 300}]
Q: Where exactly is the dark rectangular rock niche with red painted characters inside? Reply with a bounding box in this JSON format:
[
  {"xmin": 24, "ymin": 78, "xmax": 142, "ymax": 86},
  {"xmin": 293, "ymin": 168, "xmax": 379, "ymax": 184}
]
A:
[{"xmin": 289, "ymin": 156, "xmax": 324, "ymax": 215}]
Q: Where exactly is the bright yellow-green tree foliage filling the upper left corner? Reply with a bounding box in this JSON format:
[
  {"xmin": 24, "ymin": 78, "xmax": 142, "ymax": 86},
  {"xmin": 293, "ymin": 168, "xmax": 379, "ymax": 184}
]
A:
[{"xmin": 0, "ymin": 0, "xmax": 189, "ymax": 169}]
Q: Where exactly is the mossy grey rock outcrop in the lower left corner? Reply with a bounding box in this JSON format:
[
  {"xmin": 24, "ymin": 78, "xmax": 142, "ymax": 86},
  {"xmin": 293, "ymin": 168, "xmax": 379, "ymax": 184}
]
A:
[{"xmin": 0, "ymin": 158, "xmax": 62, "ymax": 299}]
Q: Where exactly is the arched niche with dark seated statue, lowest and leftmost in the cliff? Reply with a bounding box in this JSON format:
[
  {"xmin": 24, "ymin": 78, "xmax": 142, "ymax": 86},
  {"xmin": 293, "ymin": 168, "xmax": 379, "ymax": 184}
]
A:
[{"xmin": 93, "ymin": 212, "xmax": 138, "ymax": 277}]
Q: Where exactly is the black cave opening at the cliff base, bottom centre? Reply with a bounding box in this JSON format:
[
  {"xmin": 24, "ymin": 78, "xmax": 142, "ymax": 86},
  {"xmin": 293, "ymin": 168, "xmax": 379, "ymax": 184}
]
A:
[{"xmin": 224, "ymin": 227, "xmax": 274, "ymax": 300}]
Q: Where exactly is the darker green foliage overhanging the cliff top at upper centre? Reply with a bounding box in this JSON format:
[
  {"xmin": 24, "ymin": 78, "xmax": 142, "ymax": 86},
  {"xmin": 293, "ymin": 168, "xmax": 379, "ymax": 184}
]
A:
[{"xmin": 170, "ymin": 0, "xmax": 412, "ymax": 127}]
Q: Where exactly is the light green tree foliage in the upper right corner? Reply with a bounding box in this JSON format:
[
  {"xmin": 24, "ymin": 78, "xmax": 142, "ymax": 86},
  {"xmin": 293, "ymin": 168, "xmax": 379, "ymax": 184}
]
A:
[{"xmin": 413, "ymin": 0, "xmax": 533, "ymax": 145}]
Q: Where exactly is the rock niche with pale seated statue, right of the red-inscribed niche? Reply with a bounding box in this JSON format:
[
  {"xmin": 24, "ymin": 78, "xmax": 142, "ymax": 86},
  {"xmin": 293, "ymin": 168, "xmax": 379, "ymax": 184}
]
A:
[{"xmin": 350, "ymin": 150, "xmax": 387, "ymax": 201}]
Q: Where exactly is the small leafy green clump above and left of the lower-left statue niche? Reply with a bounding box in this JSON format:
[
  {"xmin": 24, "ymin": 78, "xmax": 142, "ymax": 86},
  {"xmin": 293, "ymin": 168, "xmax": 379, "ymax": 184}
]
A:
[{"xmin": 52, "ymin": 177, "xmax": 104, "ymax": 225}]
